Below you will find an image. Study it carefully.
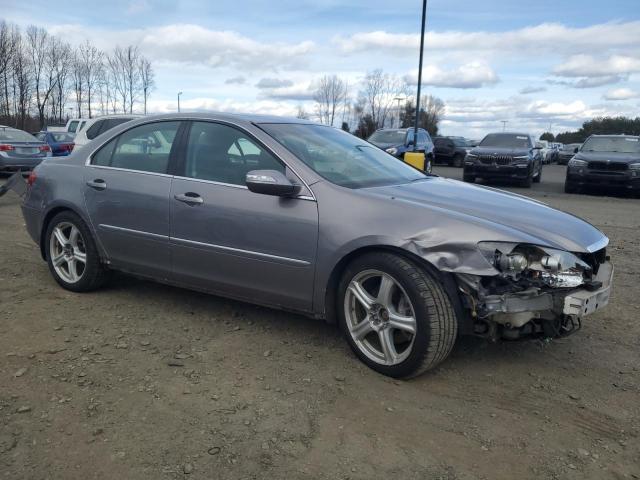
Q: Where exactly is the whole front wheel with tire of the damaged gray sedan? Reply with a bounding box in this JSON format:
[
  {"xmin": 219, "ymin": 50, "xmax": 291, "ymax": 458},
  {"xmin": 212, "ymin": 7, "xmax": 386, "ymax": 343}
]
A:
[{"xmin": 337, "ymin": 253, "xmax": 458, "ymax": 378}]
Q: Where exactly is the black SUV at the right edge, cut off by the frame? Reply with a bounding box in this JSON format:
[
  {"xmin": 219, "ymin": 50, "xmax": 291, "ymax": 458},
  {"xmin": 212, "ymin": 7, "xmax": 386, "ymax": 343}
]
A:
[{"xmin": 564, "ymin": 135, "xmax": 640, "ymax": 194}]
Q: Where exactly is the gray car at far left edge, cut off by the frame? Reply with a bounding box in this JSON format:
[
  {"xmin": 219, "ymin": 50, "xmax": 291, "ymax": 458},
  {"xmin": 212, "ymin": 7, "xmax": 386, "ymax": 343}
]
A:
[{"xmin": 0, "ymin": 125, "xmax": 51, "ymax": 174}]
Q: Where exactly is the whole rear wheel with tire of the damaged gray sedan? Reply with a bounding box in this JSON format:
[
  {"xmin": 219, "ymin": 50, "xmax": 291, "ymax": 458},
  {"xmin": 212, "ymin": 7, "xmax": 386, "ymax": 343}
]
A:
[{"xmin": 45, "ymin": 211, "xmax": 108, "ymax": 292}]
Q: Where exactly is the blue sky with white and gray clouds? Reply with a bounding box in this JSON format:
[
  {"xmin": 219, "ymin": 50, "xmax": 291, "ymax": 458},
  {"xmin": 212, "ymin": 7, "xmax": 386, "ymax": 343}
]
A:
[{"xmin": 0, "ymin": 0, "xmax": 640, "ymax": 138}]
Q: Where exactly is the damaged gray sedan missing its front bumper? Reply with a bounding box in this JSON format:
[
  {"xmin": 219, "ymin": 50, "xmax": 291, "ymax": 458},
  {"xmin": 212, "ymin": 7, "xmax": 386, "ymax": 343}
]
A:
[{"xmin": 16, "ymin": 113, "xmax": 612, "ymax": 377}]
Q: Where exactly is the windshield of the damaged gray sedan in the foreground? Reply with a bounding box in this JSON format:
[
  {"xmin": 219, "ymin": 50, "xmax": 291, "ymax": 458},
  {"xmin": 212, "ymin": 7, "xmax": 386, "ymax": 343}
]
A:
[{"xmin": 261, "ymin": 123, "xmax": 426, "ymax": 188}]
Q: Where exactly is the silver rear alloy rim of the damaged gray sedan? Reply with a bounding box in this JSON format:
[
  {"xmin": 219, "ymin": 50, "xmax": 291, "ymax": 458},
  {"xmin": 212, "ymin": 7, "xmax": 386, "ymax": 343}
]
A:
[{"xmin": 49, "ymin": 222, "xmax": 87, "ymax": 283}]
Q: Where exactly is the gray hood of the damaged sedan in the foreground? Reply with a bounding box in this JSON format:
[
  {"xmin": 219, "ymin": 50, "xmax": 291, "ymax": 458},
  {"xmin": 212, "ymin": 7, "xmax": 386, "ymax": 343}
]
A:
[{"xmin": 366, "ymin": 177, "xmax": 607, "ymax": 252}]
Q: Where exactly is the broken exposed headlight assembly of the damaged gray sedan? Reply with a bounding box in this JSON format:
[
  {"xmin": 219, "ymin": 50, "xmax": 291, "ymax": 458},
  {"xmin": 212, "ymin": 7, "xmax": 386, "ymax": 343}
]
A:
[{"xmin": 478, "ymin": 242, "xmax": 591, "ymax": 288}]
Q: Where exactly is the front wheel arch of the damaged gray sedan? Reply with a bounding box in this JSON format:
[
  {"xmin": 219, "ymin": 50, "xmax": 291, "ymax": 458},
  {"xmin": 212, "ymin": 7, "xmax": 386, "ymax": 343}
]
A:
[{"xmin": 324, "ymin": 245, "xmax": 472, "ymax": 334}]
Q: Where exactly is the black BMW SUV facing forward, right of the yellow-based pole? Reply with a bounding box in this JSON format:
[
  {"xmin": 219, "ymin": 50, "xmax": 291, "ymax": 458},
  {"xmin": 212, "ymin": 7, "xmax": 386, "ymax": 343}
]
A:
[{"xmin": 463, "ymin": 132, "xmax": 542, "ymax": 187}]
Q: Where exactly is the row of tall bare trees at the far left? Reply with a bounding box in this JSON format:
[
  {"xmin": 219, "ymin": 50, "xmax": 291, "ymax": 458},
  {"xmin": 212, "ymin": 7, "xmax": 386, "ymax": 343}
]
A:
[{"xmin": 0, "ymin": 20, "xmax": 155, "ymax": 131}]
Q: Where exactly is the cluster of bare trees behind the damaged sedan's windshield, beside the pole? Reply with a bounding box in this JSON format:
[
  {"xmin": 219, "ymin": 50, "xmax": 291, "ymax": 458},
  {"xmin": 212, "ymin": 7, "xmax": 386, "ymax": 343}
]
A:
[{"xmin": 306, "ymin": 69, "xmax": 445, "ymax": 138}]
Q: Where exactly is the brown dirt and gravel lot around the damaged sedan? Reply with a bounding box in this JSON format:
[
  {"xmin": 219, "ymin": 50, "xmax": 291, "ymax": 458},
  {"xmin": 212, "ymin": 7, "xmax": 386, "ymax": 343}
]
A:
[{"xmin": 0, "ymin": 166, "xmax": 640, "ymax": 479}]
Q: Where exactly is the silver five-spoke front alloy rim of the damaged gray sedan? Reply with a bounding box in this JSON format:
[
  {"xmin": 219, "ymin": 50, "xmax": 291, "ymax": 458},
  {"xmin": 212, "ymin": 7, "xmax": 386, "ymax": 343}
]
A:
[{"xmin": 344, "ymin": 270, "xmax": 417, "ymax": 365}]
